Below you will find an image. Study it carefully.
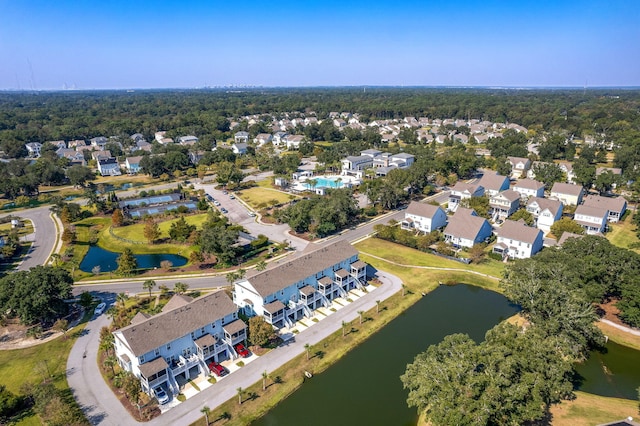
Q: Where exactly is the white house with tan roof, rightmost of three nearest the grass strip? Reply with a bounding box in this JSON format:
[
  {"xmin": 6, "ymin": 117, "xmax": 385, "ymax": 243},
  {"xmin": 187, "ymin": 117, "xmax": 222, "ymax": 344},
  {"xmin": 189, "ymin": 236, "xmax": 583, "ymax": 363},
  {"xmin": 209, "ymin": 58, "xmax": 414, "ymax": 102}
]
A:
[{"xmin": 493, "ymin": 220, "xmax": 543, "ymax": 259}]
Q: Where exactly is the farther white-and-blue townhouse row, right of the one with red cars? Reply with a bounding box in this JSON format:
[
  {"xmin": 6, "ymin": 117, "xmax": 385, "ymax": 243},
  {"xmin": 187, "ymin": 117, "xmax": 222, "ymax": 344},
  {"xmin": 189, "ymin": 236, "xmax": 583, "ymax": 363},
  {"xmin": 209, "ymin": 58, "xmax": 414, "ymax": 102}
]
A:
[{"xmin": 233, "ymin": 240, "xmax": 367, "ymax": 328}]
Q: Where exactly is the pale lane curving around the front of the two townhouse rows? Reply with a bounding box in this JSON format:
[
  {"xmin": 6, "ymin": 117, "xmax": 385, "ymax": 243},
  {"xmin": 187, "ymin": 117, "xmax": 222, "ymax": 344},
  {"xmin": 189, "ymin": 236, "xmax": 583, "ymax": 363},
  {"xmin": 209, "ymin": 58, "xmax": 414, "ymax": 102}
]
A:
[{"xmin": 67, "ymin": 271, "xmax": 402, "ymax": 425}]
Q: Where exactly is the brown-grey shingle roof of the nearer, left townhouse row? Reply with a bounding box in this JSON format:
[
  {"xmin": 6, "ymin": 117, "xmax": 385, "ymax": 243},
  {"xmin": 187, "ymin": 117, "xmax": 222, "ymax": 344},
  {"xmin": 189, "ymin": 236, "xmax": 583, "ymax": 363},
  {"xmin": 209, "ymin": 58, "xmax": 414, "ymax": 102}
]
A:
[{"xmin": 116, "ymin": 291, "xmax": 238, "ymax": 356}]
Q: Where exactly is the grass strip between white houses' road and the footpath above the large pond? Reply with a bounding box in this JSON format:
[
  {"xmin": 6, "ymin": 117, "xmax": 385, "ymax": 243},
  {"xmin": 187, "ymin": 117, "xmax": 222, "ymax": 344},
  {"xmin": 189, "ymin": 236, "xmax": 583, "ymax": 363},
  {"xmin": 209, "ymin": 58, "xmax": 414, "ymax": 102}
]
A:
[{"xmin": 355, "ymin": 238, "xmax": 504, "ymax": 278}]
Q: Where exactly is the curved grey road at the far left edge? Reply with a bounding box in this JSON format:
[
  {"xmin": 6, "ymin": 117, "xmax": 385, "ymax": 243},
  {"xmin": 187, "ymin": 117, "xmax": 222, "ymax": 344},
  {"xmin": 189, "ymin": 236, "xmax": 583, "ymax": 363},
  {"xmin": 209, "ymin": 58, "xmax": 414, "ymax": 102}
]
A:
[{"xmin": 1, "ymin": 206, "xmax": 62, "ymax": 271}]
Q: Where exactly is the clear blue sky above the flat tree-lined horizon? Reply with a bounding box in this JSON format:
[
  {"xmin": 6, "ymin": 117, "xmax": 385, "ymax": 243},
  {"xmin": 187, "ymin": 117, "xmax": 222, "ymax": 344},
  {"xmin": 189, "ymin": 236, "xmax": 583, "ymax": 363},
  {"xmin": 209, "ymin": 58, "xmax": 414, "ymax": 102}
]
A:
[{"xmin": 0, "ymin": 0, "xmax": 640, "ymax": 89}]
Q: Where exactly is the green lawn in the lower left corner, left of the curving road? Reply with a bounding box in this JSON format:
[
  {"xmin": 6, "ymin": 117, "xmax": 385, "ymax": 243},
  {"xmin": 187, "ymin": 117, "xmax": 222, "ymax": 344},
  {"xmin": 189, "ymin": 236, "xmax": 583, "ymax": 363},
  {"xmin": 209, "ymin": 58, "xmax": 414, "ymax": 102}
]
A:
[{"xmin": 0, "ymin": 321, "xmax": 85, "ymax": 426}]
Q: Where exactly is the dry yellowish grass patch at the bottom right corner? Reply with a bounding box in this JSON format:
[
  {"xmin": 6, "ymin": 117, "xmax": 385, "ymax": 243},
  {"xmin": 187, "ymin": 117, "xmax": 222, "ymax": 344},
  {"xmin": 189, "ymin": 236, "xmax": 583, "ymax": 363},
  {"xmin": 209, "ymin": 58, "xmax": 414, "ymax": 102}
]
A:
[{"xmin": 551, "ymin": 391, "xmax": 640, "ymax": 426}]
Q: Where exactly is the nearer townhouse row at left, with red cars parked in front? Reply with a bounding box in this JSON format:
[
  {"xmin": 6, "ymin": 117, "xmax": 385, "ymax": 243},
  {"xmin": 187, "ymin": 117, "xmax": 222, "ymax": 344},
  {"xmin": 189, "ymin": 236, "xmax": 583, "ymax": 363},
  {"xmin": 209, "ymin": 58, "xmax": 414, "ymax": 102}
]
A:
[{"xmin": 113, "ymin": 291, "xmax": 247, "ymax": 394}]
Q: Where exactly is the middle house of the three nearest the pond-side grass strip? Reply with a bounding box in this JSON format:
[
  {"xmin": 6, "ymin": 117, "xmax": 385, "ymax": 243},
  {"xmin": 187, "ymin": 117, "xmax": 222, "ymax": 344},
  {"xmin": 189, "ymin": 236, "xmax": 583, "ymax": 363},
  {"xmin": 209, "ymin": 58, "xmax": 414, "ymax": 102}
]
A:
[{"xmin": 444, "ymin": 207, "xmax": 492, "ymax": 248}]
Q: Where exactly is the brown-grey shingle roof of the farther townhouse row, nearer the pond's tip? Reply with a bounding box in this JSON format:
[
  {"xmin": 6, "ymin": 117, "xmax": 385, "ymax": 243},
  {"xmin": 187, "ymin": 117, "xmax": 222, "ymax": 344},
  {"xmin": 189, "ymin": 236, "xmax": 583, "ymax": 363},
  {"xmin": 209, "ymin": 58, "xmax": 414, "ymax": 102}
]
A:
[{"xmin": 247, "ymin": 240, "xmax": 358, "ymax": 297}]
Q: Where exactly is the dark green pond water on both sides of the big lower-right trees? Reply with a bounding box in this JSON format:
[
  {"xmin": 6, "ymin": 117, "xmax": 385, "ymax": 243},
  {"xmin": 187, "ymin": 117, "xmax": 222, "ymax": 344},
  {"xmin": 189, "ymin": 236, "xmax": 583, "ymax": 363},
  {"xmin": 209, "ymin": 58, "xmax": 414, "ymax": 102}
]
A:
[{"xmin": 253, "ymin": 285, "xmax": 640, "ymax": 426}]
